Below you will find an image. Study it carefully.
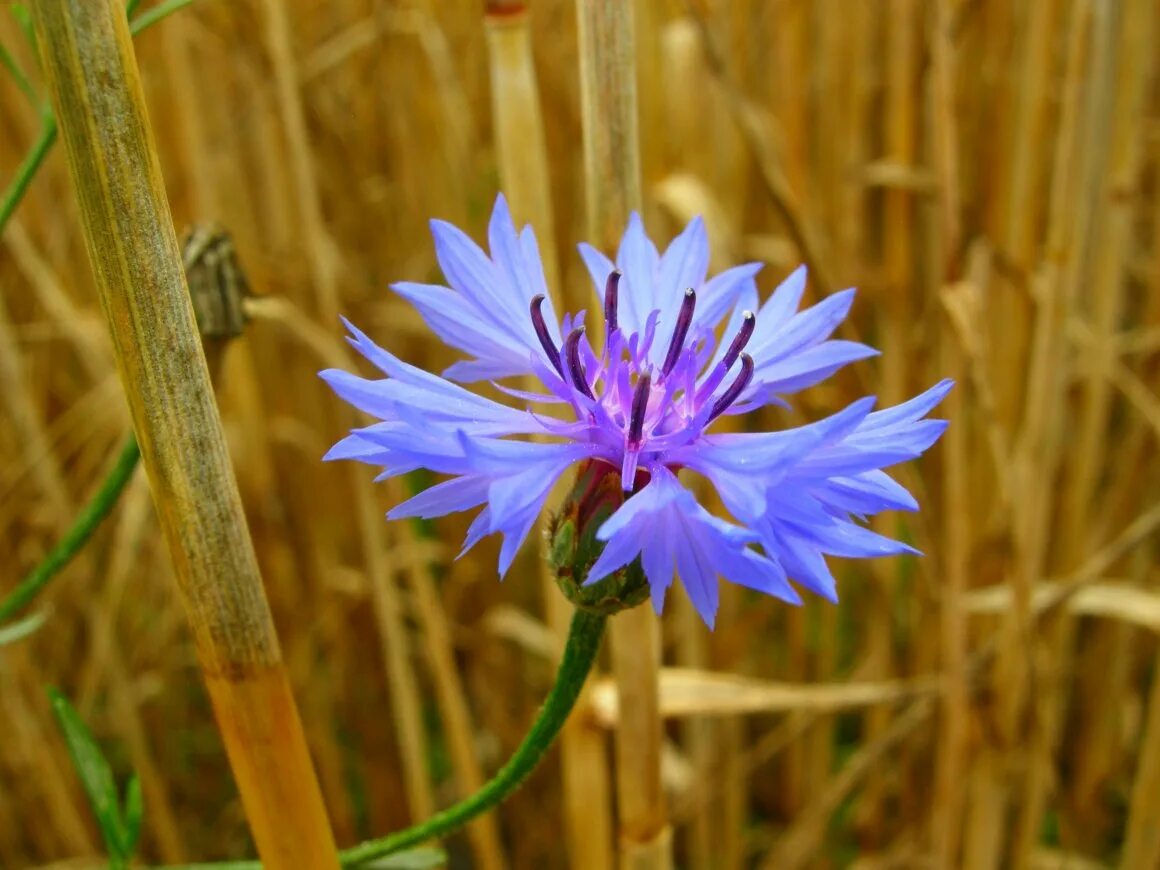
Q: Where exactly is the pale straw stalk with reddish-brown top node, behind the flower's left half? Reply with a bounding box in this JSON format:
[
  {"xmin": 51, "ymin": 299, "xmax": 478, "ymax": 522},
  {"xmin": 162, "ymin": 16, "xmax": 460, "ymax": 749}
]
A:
[{"xmin": 484, "ymin": 2, "xmax": 612, "ymax": 870}]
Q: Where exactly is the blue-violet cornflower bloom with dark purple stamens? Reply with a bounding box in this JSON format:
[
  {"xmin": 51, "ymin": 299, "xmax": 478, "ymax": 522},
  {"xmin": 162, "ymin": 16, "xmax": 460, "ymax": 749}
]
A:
[{"xmin": 321, "ymin": 196, "xmax": 951, "ymax": 626}]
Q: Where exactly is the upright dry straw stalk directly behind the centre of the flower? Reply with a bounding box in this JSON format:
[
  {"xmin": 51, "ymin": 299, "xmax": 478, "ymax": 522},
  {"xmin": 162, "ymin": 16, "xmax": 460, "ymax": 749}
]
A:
[{"xmin": 577, "ymin": 0, "xmax": 672, "ymax": 870}]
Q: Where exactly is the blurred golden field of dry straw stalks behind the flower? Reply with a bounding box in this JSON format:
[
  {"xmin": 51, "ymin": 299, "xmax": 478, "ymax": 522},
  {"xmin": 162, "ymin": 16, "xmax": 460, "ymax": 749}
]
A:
[{"xmin": 0, "ymin": 0, "xmax": 1160, "ymax": 869}]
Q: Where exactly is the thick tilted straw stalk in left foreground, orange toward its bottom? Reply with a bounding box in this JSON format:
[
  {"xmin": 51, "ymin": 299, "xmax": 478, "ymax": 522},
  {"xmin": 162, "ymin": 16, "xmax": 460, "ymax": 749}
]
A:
[{"xmin": 32, "ymin": 0, "xmax": 338, "ymax": 868}]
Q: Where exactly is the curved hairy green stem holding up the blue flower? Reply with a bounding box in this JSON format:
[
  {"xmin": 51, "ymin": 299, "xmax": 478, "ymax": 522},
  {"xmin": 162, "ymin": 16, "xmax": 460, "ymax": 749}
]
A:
[{"xmin": 339, "ymin": 609, "xmax": 608, "ymax": 867}]
